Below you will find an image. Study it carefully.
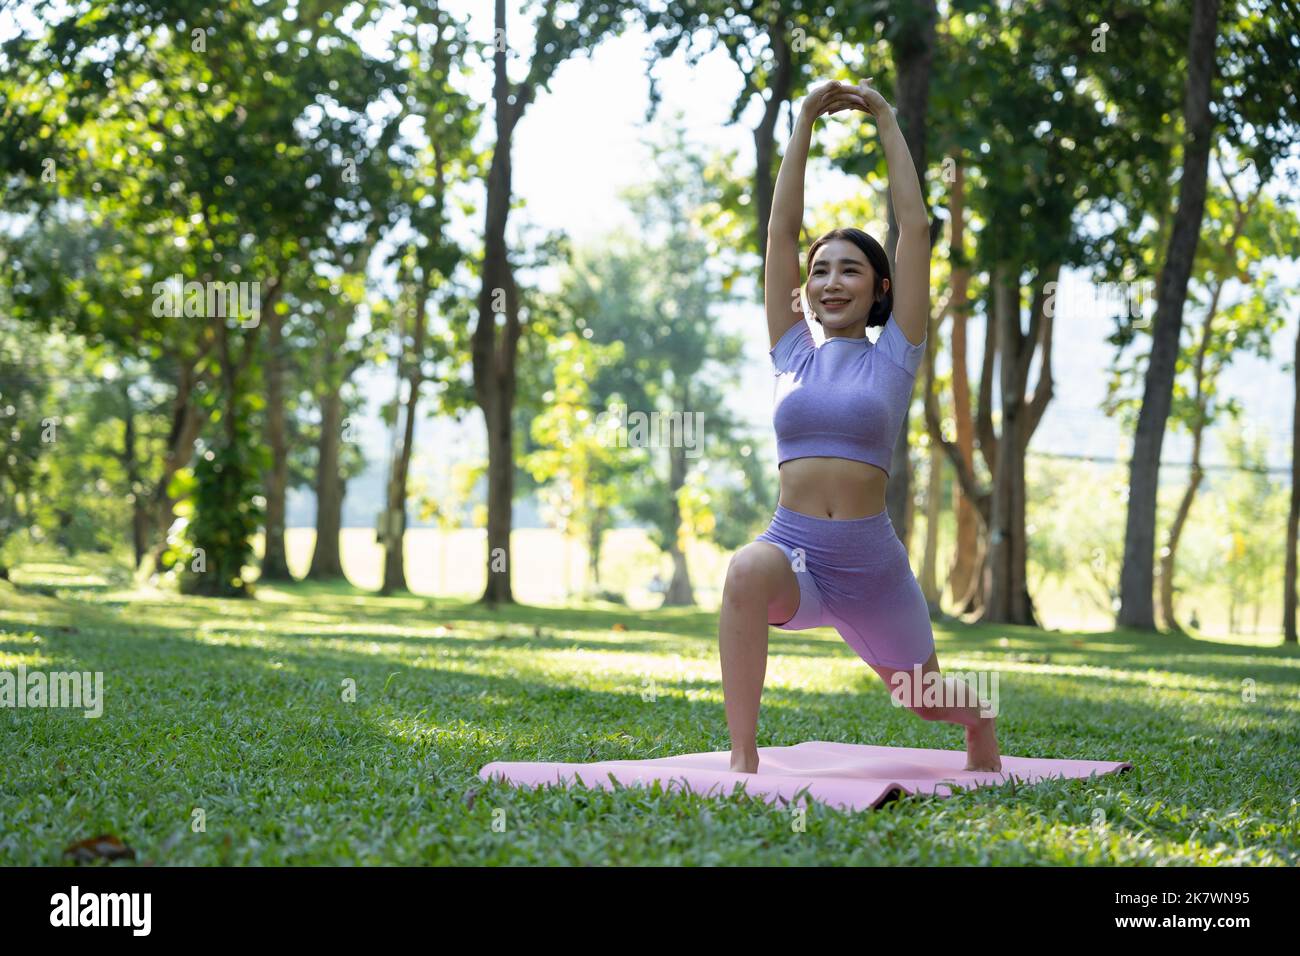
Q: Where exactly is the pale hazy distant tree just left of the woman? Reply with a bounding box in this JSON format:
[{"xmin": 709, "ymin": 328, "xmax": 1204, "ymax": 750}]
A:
[{"xmin": 566, "ymin": 125, "xmax": 753, "ymax": 606}]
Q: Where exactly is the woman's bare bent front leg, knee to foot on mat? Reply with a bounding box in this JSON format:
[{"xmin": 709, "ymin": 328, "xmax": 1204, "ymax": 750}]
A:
[{"xmin": 718, "ymin": 541, "xmax": 800, "ymax": 774}]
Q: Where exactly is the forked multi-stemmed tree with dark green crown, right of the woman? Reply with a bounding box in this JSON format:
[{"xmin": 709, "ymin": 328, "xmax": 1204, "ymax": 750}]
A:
[{"xmin": 926, "ymin": 5, "xmax": 1166, "ymax": 623}]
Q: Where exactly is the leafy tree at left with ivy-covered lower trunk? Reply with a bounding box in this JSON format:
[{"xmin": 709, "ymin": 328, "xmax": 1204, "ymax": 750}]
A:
[{"xmin": 0, "ymin": 0, "xmax": 400, "ymax": 593}]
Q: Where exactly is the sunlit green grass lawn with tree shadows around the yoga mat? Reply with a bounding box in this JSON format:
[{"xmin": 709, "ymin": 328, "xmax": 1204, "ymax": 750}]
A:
[{"xmin": 0, "ymin": 563, "xmax": 1300, "ymax": 865}]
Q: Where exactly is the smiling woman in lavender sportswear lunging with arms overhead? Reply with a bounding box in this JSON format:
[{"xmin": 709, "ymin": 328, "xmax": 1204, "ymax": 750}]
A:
[{"xmin": 719, "ymin": 77, "xmax": 1002, "ymax": 773}]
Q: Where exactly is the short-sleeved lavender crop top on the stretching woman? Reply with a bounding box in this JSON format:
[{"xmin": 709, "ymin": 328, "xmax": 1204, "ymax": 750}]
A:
[{"xmin": 768, "ymin": 312, "xmax": 926, "ymax": 473}]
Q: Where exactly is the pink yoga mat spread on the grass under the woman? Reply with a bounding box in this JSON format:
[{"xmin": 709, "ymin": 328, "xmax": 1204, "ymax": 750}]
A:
[{"xmin": 478, "ymin": 740, "xmax": 1132, "ymax": 810}]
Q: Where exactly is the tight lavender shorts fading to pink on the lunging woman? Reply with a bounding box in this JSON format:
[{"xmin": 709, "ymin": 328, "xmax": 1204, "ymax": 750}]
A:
[{"xmin": 755, "ymin": 505, "xmax": 935, "ymax": 671}]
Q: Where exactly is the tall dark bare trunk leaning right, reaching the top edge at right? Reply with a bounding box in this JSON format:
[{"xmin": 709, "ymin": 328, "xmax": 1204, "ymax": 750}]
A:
[{"xmin": 1117, "ymin": 0, "xmax": 1219, "ymax": 631}]
